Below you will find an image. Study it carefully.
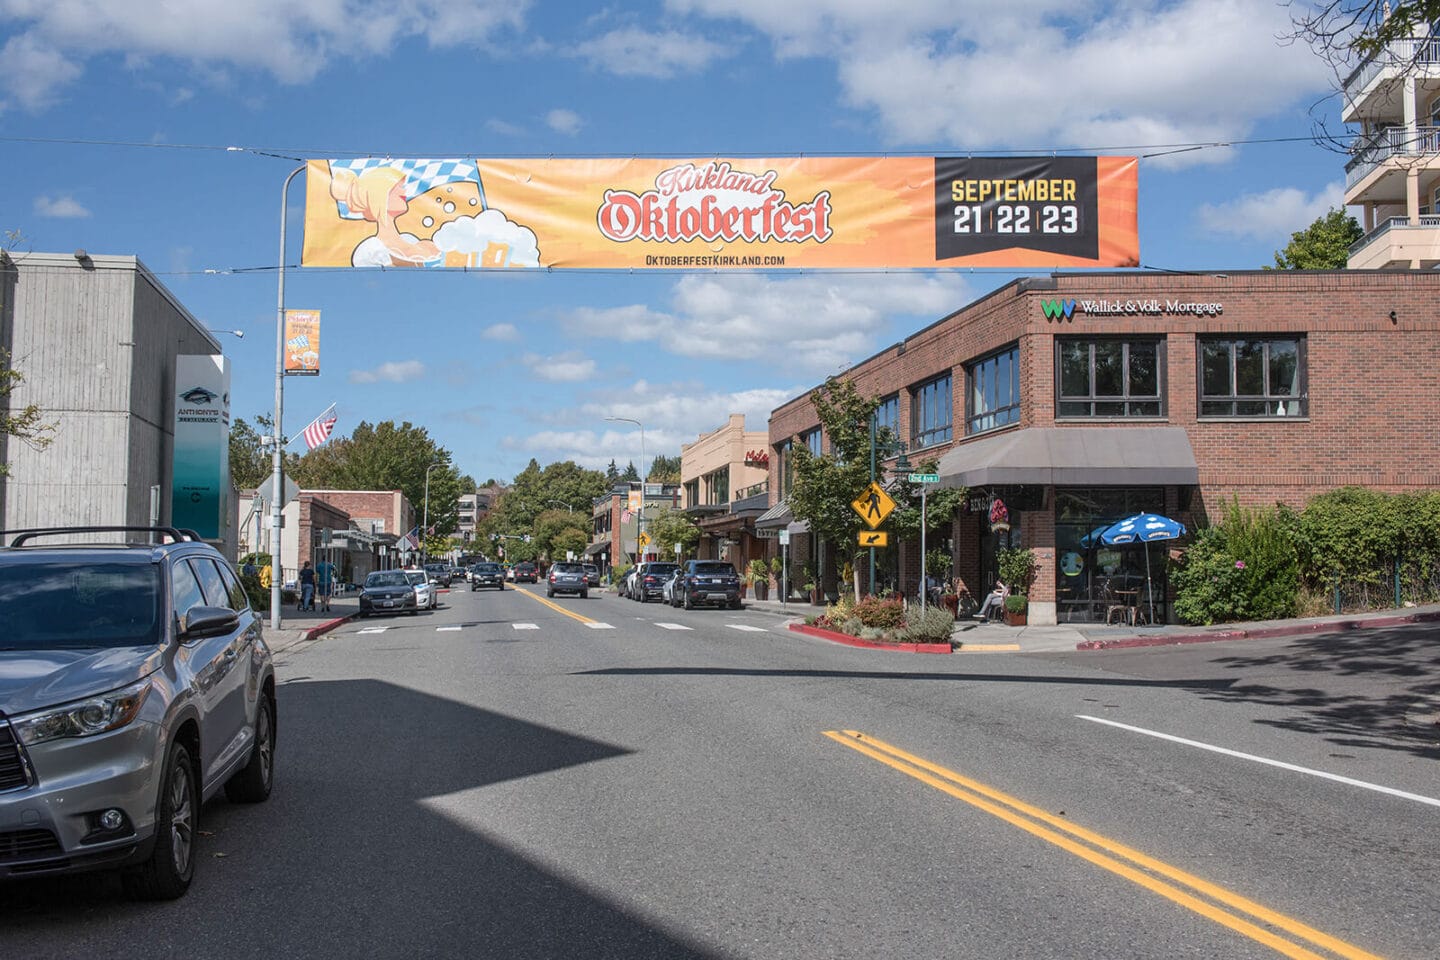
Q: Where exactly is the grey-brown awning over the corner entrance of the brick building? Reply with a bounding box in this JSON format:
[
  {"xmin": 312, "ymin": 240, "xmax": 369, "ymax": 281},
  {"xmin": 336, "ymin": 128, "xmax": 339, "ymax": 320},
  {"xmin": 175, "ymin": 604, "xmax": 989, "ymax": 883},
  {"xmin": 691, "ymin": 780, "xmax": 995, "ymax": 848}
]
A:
[{"xmin": 937, "ymin": 426, "xmax": 1200, "ymax": 488}]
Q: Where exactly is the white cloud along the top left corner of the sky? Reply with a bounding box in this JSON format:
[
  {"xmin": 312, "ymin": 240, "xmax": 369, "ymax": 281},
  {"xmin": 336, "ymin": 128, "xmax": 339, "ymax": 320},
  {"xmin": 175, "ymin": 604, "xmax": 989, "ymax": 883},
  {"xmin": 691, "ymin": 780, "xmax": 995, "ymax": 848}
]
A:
[{"xmin": 0, "ymin": 0, "xmax": 530, "ymax": 109}]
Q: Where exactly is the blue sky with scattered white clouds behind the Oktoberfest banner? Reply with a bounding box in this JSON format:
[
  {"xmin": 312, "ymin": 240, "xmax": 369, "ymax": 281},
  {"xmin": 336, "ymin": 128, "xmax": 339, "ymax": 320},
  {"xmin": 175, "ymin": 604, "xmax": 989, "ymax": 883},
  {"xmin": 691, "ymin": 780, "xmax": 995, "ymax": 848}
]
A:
[{"xmin": 0, "ymin": 0, "xmax": 1344, "ymax": 481}]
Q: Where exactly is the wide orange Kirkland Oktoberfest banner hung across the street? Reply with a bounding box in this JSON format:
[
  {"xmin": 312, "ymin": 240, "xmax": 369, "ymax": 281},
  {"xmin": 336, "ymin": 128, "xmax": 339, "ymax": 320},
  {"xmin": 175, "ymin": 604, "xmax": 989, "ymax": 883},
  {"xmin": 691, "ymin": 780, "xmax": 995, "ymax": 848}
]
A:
[{"xmin": 301, "ymin": 157, "xmax": 1140, "ymax": 271}]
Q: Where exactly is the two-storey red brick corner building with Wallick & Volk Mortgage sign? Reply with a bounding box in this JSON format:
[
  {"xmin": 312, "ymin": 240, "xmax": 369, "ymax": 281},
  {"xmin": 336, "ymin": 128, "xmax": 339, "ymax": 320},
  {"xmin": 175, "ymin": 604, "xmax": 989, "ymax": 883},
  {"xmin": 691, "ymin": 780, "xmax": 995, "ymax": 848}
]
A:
[{"xmin": 768, "ymin": 271, "xmax": 1440, "ymax": 623}]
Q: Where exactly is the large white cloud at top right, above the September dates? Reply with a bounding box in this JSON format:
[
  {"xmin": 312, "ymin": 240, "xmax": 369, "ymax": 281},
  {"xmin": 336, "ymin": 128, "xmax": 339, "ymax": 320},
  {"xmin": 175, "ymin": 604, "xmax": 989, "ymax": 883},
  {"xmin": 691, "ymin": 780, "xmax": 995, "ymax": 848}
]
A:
[{"xmin": 670, "ymin": 0, "xmax": 1331, "ymax": 166}]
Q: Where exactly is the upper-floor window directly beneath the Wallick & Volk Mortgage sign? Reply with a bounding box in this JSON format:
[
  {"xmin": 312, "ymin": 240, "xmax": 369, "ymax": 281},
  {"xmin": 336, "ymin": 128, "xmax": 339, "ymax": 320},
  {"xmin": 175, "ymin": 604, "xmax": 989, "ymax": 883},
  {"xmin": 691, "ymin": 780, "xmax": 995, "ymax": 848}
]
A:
[{"xmin": 1056, "ymin": 340, "xmax": 1165, "ymax": 417}]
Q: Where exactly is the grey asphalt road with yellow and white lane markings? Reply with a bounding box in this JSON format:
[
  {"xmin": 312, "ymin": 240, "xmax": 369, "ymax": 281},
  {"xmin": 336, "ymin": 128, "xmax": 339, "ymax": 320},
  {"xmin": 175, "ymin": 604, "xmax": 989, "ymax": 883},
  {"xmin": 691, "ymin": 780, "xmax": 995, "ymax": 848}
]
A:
[{"xmin": 0, "ymin": 586, "xmax": 1440, "ymax": 960}]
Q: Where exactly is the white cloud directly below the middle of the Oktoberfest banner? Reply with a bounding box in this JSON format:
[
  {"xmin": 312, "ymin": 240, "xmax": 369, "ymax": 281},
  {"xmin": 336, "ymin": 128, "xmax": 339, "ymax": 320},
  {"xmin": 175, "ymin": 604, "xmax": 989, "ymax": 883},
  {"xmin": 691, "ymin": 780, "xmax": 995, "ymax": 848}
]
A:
[{"xmin": 566, "ymin": 273, "xmax": 971, "ymax": 376}]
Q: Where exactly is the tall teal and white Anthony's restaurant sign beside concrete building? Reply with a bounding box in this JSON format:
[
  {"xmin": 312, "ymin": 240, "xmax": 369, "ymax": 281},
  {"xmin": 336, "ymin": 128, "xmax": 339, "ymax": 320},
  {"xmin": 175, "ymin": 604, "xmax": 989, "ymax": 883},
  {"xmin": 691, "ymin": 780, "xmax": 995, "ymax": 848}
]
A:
[{"xmin": 170, "ymin": 354, "xmax": 230, "ymax": 540}]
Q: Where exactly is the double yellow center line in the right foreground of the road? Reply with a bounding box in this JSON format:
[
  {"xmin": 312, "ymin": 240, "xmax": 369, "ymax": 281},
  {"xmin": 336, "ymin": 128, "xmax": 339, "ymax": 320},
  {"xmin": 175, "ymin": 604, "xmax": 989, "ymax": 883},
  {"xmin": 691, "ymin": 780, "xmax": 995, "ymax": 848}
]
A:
[{"xmin": 825, "ymin": 730, "xmax": 1380, "ymax": 960}]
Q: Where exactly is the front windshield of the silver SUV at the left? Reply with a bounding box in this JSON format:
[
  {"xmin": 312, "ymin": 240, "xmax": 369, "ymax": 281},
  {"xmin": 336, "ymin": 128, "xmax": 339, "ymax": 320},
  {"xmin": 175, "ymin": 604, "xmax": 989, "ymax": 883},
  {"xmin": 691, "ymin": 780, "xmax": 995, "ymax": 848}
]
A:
[{"xmin": 0, "ymin": 561, "xmax": 161, "ymax": 651}]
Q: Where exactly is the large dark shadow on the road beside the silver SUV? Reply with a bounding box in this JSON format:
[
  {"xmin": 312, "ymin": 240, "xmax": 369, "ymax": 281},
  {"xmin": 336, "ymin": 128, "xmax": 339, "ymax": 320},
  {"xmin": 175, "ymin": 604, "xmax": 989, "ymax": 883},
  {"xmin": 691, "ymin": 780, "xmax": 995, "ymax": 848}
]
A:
[{"xmin": 0, "ymin": 681, "xmax": 716, "ymax": 960}]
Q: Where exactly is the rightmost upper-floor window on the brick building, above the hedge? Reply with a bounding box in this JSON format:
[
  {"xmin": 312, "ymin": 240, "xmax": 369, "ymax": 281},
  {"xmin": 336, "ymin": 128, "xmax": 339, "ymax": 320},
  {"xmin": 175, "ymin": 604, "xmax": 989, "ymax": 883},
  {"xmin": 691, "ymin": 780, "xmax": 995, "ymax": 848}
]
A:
[{"xmin": 1200, "ymin": 337, "xmax": 1309, "ymax": 417}]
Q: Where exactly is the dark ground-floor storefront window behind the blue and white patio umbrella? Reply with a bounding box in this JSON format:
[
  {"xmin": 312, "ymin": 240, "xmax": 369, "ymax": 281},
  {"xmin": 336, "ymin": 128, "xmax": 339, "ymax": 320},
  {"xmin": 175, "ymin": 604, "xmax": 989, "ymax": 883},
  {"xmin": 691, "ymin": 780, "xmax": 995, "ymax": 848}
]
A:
[{"xmin": 1056, "ymin": 486, "xmax": 1169, "ymax": 623}]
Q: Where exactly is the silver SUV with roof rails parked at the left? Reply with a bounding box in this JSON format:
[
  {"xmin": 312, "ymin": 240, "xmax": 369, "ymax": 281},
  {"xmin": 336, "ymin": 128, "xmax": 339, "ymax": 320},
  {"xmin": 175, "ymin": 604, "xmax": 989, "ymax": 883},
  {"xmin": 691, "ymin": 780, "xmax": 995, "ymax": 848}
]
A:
[{"xmin": 0, "ymin": 527, "xmax": 275, "ymax": 900}]
